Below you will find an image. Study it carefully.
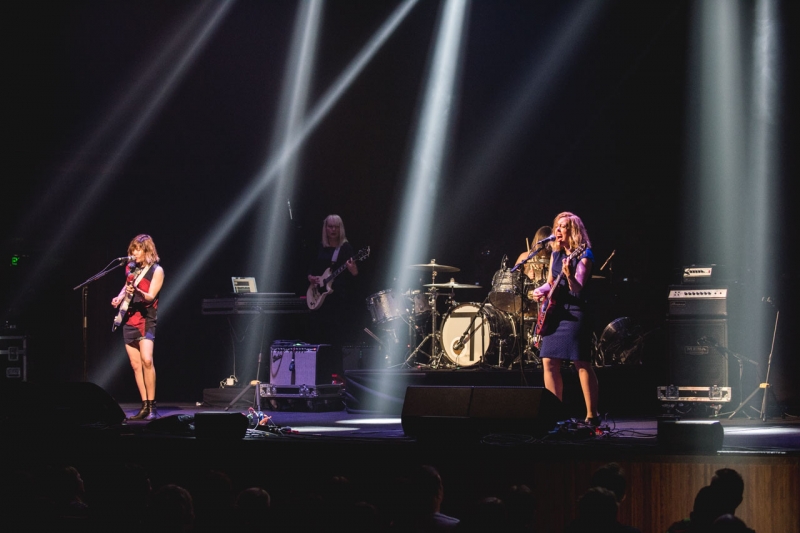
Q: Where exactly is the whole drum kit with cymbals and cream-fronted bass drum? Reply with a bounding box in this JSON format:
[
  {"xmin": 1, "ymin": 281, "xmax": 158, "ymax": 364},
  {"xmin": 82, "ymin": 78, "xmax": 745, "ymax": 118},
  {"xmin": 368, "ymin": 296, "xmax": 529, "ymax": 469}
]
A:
[{"xmin": 367, "ymin": 257, "xmax": 547, "ymax": 369}]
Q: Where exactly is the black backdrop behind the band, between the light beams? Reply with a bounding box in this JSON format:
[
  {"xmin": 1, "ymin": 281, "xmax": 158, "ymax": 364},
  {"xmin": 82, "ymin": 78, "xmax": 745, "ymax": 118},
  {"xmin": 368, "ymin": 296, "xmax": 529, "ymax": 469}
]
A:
[{"xmin": 0, "ymin": 0, "xmax": 800, "ymax": 402}]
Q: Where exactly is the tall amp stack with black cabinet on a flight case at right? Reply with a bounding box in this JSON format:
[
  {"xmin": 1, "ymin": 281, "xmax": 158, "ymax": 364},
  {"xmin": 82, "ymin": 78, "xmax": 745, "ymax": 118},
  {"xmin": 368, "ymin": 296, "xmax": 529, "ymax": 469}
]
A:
[{"xmin": 658, "ymin": 265, "xmax": 731, "ymax": 413}]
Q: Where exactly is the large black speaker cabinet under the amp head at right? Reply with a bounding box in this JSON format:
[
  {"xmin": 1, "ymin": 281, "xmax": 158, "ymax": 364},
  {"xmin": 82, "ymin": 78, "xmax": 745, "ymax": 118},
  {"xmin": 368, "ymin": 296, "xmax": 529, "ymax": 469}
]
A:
[{"xmin": 667, "ymin": 319, "xmax": 728, "ymax": 387}]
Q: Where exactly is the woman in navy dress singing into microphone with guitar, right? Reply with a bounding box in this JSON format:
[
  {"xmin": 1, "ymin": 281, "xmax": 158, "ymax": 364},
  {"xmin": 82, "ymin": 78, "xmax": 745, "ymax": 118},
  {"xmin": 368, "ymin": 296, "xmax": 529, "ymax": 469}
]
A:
[{"xmin": 533, "ymin": 211, "xmax": 600, "ymax": 426}]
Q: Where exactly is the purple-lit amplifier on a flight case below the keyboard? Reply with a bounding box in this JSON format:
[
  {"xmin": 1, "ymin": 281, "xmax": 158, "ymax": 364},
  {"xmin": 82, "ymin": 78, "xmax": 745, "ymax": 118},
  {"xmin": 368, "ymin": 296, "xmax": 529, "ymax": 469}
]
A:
[{"xmin": 269, "ymin": 342, "xmax": 342, "ymax": 385}]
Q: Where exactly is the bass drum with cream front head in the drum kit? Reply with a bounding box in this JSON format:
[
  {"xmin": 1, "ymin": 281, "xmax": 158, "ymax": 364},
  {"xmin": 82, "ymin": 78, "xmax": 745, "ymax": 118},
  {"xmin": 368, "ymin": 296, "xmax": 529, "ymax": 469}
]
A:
[{"xmin": 442, "ymin": 303, "xmax": 516, "ymax": 367}]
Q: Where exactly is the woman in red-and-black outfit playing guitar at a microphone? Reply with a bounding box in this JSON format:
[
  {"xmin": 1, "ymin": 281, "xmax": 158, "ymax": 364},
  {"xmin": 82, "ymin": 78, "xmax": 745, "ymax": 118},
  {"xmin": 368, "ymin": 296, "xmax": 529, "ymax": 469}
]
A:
[{"xmin": 111, "ymin": 234, "xmax": 164, "ymax": 420}]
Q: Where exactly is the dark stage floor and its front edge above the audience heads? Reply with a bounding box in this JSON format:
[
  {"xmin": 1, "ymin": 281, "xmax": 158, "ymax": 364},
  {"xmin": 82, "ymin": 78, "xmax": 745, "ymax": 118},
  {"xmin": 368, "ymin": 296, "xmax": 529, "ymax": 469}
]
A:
[{"xmin": 3, "ymin": 368, "xmax": 800, "ymax": 531}]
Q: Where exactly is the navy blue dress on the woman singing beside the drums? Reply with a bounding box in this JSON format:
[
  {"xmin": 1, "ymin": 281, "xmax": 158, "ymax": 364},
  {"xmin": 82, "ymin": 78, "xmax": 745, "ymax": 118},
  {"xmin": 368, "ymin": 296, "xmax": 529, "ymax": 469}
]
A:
[{"xmin": 539, "ymin": 248, "xmax": 594, "ymax": 361}]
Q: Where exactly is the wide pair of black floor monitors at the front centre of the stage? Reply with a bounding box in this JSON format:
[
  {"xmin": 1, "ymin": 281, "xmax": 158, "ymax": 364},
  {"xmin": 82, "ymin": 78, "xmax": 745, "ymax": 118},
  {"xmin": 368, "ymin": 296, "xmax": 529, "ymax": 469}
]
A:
[{"xmin": 401, "ymin": 386, "xmax": 564, "ymax": 439}]
